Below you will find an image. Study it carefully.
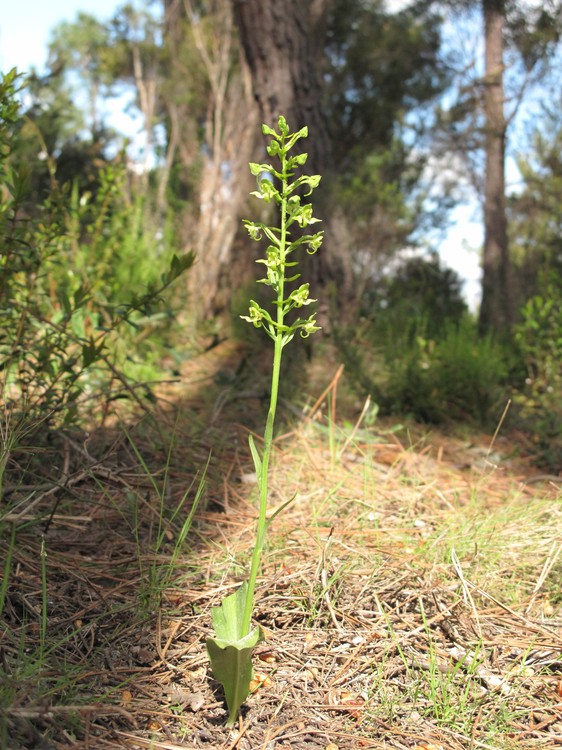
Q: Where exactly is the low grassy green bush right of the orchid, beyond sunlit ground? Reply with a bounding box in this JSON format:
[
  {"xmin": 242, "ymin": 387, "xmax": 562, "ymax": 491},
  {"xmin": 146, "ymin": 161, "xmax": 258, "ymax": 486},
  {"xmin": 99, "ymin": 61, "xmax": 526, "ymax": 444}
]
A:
[{"xmin": 336, "ymin": 309, "xmax": 512, "ymax": 426}]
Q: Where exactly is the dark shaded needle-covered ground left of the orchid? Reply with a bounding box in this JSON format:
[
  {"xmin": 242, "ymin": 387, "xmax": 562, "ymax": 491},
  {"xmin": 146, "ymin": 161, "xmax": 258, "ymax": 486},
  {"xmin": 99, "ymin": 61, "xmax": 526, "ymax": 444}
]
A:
[{"xmin": 0, "ymin": 341, "xmax": 322, "ymax": 750}]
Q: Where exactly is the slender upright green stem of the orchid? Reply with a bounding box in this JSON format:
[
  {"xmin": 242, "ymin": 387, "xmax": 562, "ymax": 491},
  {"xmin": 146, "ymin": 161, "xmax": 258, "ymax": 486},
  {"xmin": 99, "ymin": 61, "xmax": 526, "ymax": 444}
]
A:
[{"xmin": 242, "ymin": 144, "xmax": 287, "ymax": 636}]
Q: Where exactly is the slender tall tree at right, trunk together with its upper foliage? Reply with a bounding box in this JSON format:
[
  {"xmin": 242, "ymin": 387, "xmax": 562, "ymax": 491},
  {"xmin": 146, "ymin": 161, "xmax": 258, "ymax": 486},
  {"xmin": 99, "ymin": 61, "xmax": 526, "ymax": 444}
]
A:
[{"xmin": 436, "ymin": 0, "xmax": 560, "ymax": 335}]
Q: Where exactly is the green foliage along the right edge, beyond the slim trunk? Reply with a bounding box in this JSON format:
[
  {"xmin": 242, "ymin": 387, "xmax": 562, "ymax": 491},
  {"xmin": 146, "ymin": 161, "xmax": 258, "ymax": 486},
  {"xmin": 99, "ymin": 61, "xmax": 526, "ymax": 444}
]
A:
[{"xmin": 509, "ymin": 101, "xmax": 562, "ymax": 470}]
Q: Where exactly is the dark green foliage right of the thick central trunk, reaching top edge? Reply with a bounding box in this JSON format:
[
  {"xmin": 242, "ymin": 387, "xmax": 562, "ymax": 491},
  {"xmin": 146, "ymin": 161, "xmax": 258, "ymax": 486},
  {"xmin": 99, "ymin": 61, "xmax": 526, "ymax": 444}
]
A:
[{"xmin": 323, "ymin": 0, "xmax": 450, "ymax": 282}]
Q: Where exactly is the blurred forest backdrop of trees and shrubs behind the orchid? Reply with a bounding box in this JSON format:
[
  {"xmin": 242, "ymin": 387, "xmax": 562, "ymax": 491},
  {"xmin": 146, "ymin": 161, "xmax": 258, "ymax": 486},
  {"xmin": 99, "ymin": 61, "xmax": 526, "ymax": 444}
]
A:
[{"xmin": 0, "ymin": 0, "xmax": 562, "ymax": 468}]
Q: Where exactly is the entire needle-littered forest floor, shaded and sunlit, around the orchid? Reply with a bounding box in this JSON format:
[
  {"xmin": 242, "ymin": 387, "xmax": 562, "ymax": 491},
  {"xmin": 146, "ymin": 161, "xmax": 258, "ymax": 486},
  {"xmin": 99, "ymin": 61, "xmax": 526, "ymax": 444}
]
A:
[{"xmin": 0, "ymin": 342, "xmax": 562, "ymax": 750}]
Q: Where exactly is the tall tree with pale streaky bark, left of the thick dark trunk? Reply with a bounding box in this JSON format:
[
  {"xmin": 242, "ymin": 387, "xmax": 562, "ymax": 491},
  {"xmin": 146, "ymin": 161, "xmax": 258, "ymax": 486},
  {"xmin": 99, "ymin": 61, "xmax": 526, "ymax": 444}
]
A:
[{"xmin": 164, "ymin": 0, "xmax": 258, "ymax": 318}]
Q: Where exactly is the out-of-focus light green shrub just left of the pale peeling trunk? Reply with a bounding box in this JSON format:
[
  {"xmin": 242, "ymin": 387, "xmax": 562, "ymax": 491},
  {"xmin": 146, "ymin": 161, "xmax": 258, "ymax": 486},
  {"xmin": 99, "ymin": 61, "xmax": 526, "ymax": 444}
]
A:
[{"xmin": 60, "ymin": 161, "xmax": 188, "ymax": 388}]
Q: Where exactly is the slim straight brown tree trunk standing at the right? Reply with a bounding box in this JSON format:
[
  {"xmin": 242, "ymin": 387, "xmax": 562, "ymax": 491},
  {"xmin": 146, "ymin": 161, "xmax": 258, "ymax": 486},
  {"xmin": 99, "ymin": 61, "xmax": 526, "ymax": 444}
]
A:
[{"xmin": 479, "ymin": 0, "xmax": 514, "ymax": 334}]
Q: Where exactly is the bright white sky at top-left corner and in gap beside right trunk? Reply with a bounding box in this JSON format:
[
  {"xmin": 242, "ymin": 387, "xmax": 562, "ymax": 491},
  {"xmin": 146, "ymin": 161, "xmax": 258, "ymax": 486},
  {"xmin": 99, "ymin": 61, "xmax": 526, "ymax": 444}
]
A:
[{"xmin": 0, "ymin": 0, "xmax": 482, "ymax": 309}]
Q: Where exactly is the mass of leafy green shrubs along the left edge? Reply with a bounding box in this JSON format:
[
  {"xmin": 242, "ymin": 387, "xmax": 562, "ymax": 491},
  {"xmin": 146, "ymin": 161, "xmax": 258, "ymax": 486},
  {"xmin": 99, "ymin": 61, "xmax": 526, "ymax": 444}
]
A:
[{"xmin": 0, "ymin": 71, "xmax": 193, "ymax": 434}]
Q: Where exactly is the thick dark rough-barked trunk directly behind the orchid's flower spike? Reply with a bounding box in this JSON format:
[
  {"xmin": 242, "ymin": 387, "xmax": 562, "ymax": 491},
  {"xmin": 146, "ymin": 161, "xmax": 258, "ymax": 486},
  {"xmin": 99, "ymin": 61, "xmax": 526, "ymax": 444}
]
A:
[{"xmin": 232, "ymin": 0, "xmax": 350, "ymax": 294}]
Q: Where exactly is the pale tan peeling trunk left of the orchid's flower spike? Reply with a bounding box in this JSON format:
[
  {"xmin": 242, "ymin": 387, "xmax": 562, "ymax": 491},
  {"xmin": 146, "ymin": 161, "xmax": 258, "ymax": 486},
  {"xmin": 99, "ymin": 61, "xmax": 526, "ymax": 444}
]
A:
[{"xmin": 162, "ymin": 0, "xmax": 258, "ymax": 320}]
